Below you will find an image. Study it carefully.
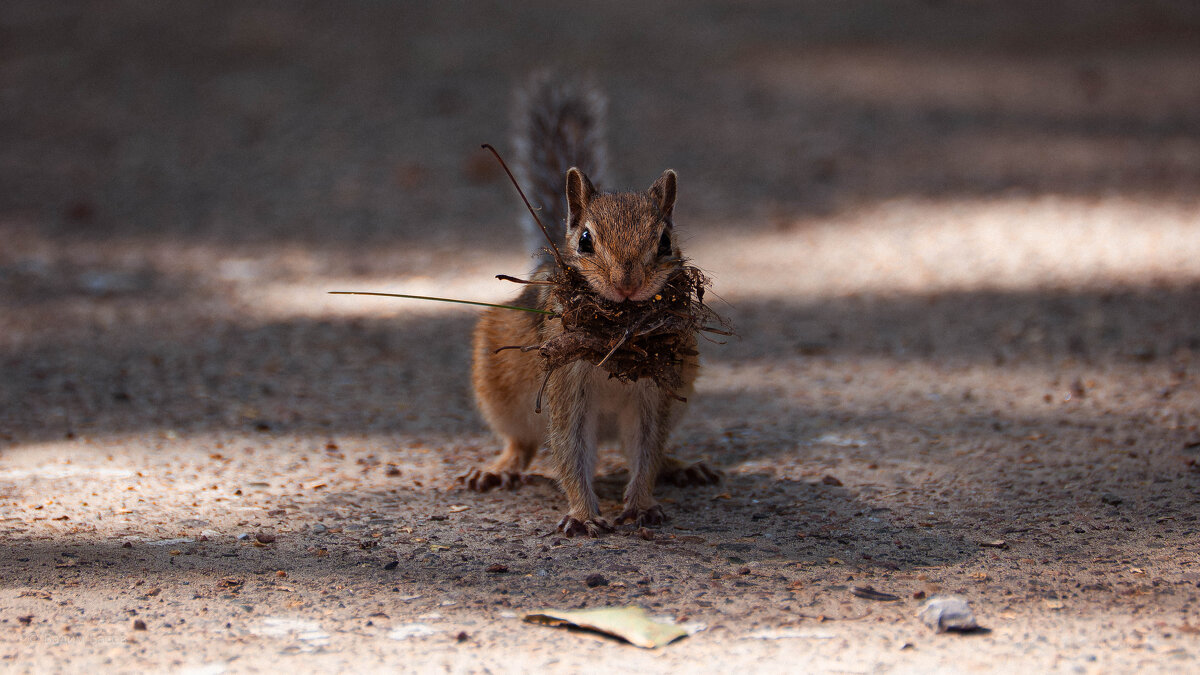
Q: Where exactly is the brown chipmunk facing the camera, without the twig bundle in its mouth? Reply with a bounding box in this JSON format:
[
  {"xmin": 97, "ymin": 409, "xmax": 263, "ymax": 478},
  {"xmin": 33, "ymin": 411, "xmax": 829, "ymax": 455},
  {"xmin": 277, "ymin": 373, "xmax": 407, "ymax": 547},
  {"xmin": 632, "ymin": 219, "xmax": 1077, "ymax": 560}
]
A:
[{"xmin": 460, "ymin": 77, "xmax": 719, "ymax": 537}]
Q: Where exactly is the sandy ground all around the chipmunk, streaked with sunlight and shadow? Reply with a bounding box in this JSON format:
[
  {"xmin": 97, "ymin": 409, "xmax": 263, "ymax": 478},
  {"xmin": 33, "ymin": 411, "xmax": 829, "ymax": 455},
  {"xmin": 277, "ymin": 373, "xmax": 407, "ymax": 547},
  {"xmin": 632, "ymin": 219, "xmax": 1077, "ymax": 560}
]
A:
[{"xmin": 0, "ymin": 1, "xmax": 1200, "ymax": 673}]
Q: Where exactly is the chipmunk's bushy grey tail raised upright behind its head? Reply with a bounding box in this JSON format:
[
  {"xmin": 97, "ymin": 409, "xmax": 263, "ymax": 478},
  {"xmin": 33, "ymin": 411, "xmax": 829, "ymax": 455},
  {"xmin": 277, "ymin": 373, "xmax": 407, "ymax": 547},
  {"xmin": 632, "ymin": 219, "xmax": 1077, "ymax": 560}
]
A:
[{"xmin": 512, "ymin": 73, "xmax": 608, "ymax": 261}]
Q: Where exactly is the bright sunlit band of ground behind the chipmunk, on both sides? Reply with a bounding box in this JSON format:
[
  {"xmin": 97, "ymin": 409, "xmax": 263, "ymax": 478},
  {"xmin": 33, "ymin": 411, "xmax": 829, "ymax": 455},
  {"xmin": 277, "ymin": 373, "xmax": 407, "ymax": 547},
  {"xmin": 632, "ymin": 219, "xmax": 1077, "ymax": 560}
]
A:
[{"xmin": 235, "ymin": 196, "xmax": 1200, "ymax": 319}]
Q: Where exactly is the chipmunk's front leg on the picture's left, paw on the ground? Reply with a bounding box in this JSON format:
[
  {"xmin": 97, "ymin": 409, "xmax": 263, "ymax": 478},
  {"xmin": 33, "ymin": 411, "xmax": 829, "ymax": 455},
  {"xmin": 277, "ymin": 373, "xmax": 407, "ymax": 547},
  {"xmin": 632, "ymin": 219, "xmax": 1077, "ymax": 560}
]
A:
[{"xmin": 546, "ymin": 364, "xmax": 612, "ymax": 537}]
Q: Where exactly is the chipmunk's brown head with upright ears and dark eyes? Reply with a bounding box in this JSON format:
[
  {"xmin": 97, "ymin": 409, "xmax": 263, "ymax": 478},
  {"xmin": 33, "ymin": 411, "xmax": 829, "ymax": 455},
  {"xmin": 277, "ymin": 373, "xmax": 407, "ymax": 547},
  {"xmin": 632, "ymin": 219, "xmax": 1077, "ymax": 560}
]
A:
[{"xmin": 564, "ymin": 168, "xmax": 683, "ymax": 303}]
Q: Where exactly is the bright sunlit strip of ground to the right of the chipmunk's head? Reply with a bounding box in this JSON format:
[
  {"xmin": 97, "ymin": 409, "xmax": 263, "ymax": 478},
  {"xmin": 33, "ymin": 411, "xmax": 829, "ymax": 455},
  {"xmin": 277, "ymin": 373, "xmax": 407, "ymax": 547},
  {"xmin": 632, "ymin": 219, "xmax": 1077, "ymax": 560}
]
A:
[{"xmin": 688, "ymin": 196, "xmax": 1200, "ymax": 301}]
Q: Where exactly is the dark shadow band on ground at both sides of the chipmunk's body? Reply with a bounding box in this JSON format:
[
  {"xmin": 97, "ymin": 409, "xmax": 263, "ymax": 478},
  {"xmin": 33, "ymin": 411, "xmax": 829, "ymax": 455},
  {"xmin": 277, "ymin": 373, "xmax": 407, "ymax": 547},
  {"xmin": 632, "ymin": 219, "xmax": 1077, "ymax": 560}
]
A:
[{"xmin": 0, "ymin": 278, "xmax": 1200, "ymax": 443}]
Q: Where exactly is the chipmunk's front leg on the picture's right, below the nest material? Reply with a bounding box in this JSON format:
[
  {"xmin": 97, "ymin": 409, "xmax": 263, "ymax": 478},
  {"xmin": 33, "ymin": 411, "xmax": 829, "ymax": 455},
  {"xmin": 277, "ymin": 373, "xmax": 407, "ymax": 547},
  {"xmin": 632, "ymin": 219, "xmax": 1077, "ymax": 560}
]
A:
[{"xmin": 617, "ymin": 383, "xmax": 671, "ymax": 526}]
